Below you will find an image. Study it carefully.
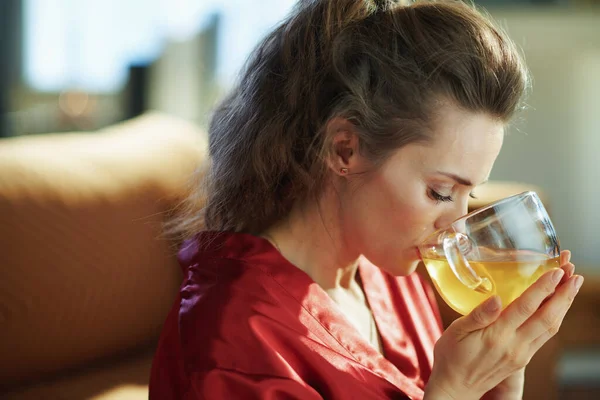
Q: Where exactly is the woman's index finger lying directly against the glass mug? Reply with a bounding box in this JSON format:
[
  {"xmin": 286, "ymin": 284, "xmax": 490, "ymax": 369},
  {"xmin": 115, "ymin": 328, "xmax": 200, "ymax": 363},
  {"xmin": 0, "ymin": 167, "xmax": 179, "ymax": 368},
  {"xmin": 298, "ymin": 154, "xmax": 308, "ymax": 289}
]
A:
[{"xmin": 501, "ymin": 268, "xmax": 565, "ymax": 330}]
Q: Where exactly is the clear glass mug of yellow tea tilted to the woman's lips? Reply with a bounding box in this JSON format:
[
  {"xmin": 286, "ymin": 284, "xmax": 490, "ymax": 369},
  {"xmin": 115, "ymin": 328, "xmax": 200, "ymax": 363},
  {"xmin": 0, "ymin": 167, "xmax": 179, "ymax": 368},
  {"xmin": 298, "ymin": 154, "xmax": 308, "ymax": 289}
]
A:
[{"xmin": 419, "ymin": 192, "xmax": 560, "ymax": 315}]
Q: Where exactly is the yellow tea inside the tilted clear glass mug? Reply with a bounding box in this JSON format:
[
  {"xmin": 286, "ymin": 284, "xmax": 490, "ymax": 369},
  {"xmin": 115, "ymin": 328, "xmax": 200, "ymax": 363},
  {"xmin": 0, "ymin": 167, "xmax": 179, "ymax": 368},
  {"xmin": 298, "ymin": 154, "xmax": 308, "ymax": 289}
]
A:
[{"xmin": 423, "ymin": 255, "xmax": 560, "ymax": 315}]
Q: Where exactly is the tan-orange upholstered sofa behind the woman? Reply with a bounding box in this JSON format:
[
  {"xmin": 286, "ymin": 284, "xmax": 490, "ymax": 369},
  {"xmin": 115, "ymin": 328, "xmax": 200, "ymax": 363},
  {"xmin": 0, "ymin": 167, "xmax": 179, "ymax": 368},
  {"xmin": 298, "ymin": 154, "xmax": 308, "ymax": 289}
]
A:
[{"xmin": 0, "ymin": 113, "xmax": 600, "ymax": 400}]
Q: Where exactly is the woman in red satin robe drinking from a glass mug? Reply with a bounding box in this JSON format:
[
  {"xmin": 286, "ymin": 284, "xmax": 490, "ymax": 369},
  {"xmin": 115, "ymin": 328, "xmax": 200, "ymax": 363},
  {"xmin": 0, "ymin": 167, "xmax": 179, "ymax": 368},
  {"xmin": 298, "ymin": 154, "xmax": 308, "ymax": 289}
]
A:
[{"xmin": 150, "ymin": 0, "xmax": 582, "ymax": 400}]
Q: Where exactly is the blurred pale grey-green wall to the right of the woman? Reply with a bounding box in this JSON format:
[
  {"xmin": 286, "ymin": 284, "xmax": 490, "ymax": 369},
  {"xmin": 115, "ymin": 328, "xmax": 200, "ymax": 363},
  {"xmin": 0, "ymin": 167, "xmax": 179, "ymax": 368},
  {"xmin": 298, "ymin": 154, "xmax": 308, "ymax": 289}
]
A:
[{"xmin": 491, "ymin": 9, "xmax": 600, "ymax": 274}]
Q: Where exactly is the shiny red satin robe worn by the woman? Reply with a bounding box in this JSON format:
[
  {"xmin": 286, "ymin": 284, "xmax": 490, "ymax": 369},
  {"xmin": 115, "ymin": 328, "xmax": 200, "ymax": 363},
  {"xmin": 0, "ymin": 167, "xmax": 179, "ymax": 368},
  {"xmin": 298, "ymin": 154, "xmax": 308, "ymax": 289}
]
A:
[{"xmin": 150, "ymin": 232, "xmax": 442, "ymax": 400}]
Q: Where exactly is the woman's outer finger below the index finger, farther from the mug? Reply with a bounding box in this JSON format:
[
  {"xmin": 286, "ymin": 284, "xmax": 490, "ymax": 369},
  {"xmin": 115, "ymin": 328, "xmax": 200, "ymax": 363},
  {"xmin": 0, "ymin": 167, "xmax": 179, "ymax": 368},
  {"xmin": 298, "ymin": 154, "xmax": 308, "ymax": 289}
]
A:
[{"xmin": 517, "ymin": 275, "xmax": 583, "ymax": 352}]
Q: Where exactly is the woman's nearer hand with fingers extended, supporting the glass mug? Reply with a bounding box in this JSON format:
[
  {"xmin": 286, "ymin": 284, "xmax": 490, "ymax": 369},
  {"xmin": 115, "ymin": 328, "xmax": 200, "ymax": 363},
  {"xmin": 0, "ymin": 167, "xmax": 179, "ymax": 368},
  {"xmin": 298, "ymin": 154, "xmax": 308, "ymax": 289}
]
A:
[{"xmin": 425, "ymin": 248, "xmax": 583, "ymax": 400}]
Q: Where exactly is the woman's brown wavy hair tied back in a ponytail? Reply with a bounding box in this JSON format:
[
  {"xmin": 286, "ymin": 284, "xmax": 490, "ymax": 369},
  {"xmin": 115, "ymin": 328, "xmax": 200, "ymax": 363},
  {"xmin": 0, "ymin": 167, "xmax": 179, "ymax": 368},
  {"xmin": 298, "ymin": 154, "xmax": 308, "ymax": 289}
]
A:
[{"xmin": 168, "ymin": 0, "xmax": 529, "ymax": 238}]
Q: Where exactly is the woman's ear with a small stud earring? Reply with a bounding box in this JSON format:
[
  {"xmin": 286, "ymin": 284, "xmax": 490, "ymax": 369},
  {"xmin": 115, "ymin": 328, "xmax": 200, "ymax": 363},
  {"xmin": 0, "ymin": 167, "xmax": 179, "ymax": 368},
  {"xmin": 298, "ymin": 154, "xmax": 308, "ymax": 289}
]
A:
[{"xmin": 325, "ymin": 117, "xmax": 364, "ymax": 176}]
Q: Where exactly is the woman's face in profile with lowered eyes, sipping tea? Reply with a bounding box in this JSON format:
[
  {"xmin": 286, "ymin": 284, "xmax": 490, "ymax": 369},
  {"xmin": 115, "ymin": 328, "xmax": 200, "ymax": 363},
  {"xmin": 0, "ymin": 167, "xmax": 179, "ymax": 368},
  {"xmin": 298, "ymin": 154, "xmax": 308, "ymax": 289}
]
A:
[{"xmin": 340, "ymin": 106, "xmax": 504, "ymax": 275}]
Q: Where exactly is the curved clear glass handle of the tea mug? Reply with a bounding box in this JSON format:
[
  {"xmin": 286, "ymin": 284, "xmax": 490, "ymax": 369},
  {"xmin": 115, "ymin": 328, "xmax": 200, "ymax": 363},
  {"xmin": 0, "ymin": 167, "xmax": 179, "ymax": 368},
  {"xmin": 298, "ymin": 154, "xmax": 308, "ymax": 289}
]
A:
[{"xmin": 443, "ymin": 232, "xmax": 493, "ymax": 294}]
